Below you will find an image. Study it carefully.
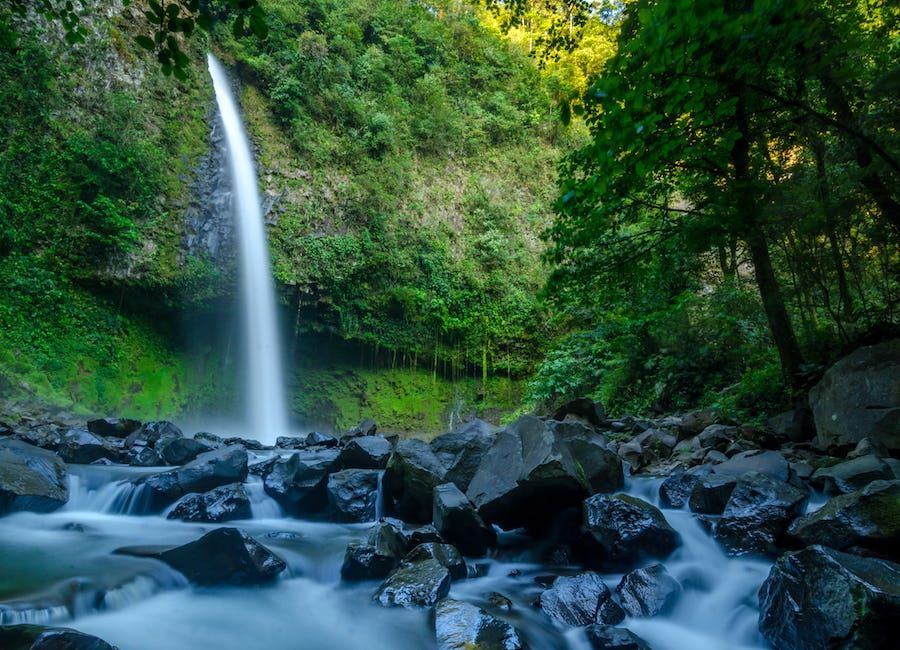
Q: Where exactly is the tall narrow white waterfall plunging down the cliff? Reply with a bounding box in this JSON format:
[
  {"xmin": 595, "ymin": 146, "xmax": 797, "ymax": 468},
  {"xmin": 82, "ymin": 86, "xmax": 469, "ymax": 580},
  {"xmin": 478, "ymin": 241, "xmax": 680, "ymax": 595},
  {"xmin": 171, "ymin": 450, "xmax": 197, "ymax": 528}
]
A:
[{"xmin": 208, "ymin": 54, "xmax": 289, "ymax": 442}]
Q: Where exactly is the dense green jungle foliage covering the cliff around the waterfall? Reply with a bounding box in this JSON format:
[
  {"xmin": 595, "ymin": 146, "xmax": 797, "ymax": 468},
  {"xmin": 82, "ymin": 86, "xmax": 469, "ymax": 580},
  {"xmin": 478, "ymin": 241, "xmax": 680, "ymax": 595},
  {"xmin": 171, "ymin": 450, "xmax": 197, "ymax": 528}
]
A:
[{"xmin": 0, "ymin": 0, "xmax": 900, "ymax": 431}]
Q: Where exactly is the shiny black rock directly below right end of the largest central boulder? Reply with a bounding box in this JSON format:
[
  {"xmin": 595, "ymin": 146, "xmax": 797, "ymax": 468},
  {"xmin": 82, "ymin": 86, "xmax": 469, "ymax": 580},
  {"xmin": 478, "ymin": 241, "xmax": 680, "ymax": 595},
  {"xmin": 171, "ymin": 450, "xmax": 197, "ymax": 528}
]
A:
[{"xmin": 578, "ymin": 494, "xmax": 681, "ymax": 567}]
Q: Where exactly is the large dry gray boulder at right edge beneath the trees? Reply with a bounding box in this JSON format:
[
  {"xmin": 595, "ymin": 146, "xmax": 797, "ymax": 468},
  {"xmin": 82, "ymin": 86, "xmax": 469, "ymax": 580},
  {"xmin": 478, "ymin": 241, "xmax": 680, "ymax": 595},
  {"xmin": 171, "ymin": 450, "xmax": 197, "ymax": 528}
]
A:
[{"xmin": 809, "ymin": 339, "xmax": 900, "ymax": 451}]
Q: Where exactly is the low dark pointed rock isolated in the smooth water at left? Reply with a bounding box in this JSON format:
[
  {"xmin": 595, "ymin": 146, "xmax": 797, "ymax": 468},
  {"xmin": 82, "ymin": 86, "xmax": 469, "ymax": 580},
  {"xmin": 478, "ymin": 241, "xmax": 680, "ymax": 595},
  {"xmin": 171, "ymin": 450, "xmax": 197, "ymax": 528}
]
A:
[{"xmin": 152, "ymin": 528, "xmax": 287, "ymax": 586}]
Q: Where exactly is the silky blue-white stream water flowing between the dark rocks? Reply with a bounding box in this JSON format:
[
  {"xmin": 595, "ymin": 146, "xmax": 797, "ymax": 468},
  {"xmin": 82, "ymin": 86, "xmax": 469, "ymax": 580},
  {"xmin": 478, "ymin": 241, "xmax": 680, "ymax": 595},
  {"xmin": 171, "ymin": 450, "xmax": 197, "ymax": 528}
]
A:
[{"xmin": 0, "ymin": 465, "xmax": 769, "ymax": 650}]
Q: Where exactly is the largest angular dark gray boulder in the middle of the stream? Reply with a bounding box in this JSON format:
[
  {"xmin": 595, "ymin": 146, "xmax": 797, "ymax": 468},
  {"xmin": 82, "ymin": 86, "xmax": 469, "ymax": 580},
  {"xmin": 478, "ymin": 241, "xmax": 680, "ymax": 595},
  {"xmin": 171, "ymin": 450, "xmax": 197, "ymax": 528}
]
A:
[{"xmin": 466, "ymin": 416, "xmax": 624, "ymax": 530}]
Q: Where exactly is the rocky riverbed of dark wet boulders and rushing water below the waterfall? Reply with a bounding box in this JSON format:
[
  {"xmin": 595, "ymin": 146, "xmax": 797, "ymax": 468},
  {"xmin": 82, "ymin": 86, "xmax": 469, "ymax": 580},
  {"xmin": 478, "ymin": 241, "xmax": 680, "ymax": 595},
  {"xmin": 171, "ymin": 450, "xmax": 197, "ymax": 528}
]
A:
[{"xmin": 0, "ymin": 342, "xmax": 900, "ymax": 650}]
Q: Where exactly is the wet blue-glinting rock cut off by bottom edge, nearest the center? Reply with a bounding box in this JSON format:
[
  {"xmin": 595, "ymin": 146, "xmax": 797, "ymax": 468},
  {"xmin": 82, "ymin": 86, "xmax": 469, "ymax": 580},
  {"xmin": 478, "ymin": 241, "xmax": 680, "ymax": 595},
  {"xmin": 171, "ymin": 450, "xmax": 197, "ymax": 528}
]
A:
[{"xmin": 434, "ymin": 598, "xmax": 525, "ymax": 650}]
